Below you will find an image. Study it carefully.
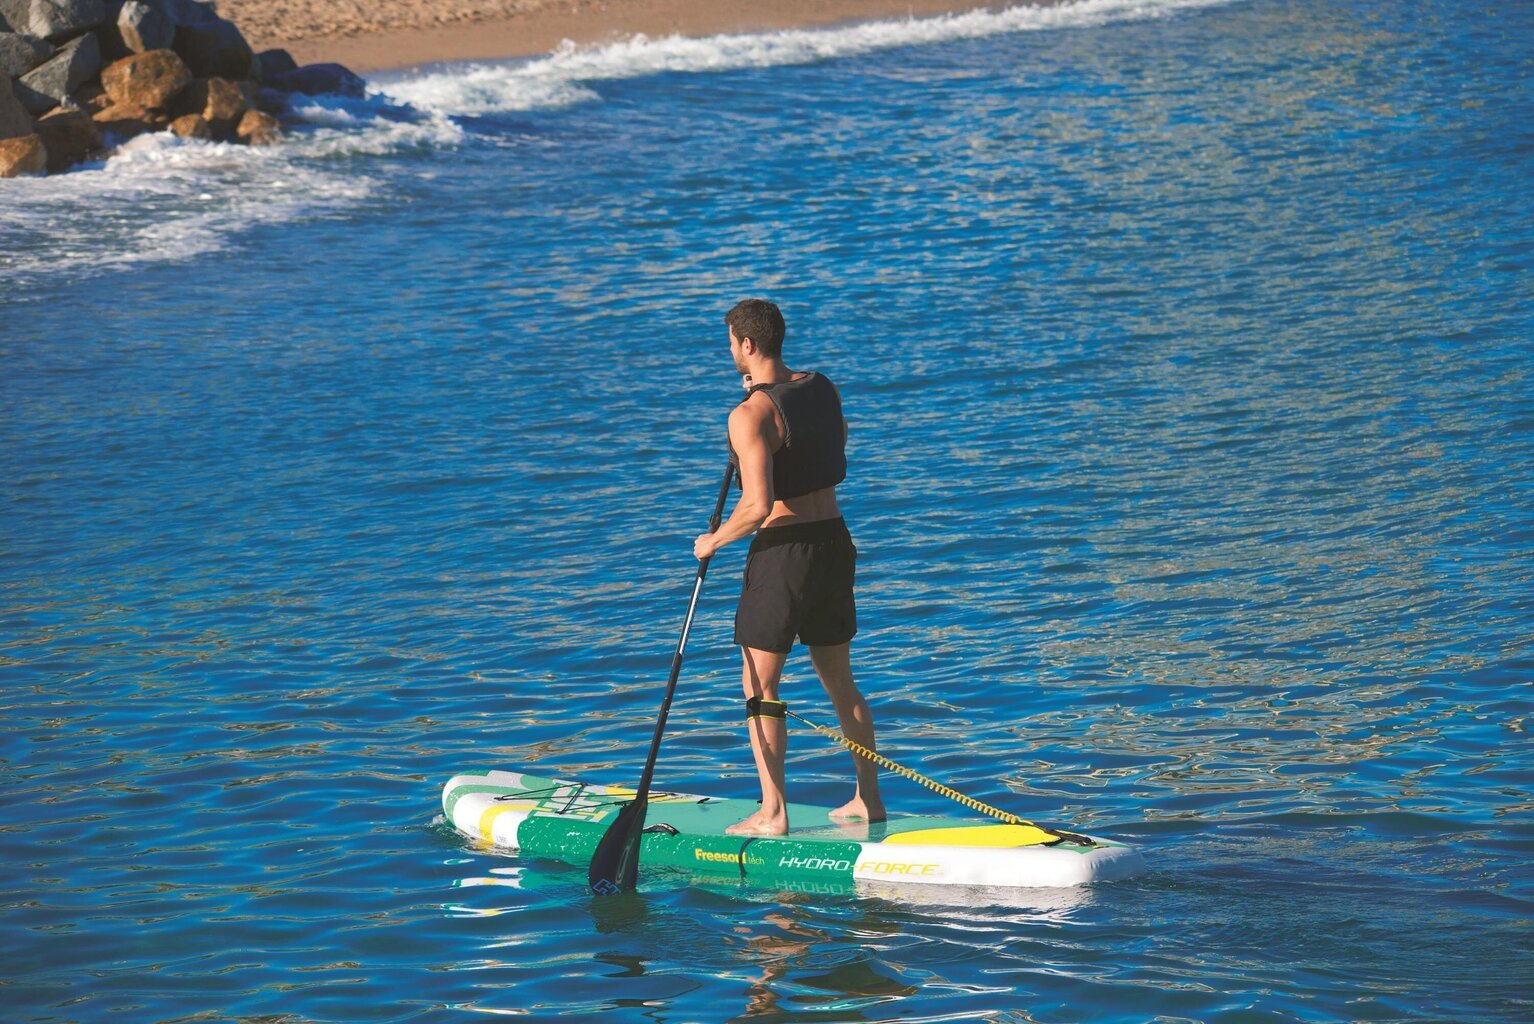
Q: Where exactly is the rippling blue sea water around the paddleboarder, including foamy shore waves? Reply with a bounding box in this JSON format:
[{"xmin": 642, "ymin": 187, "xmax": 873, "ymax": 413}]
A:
[{"xmin": 0, "ymin": 0, "xmax": 1534, "ymax": 1024}]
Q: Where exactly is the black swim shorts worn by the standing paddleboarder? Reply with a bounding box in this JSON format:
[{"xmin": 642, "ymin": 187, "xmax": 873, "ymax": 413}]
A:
[{"xmin": 735, "ymin": 518, "xmax": 858, "ymax": 655}]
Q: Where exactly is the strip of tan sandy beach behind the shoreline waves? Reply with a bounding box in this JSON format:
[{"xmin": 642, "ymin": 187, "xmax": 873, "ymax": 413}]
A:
[{"xmin": 218, "ymin": 0, "xmax": 1006, "ymax": 72}]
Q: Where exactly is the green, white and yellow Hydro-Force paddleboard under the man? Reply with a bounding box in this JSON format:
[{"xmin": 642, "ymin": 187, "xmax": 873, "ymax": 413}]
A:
[{"xmin": 442, "ymin": 771, "xmax": 1144, "ymax": 886}]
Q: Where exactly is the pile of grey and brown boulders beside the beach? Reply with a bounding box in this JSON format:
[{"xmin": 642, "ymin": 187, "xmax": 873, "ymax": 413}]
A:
[{"xmin": 0, "ymin": 0, "xmax": 362, "ymax": 178}]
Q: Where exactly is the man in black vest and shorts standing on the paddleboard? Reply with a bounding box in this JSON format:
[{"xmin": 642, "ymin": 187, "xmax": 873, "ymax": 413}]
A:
[{"xmin": 692, "ymin": 299, "xmax": 885, "ymax": 835}]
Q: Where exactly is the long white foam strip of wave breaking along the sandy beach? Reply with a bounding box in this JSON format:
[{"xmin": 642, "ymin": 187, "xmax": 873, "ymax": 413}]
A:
[{"xmin": 380, "ymin": 0, "xmax": 1229, "ymax": 115}]
